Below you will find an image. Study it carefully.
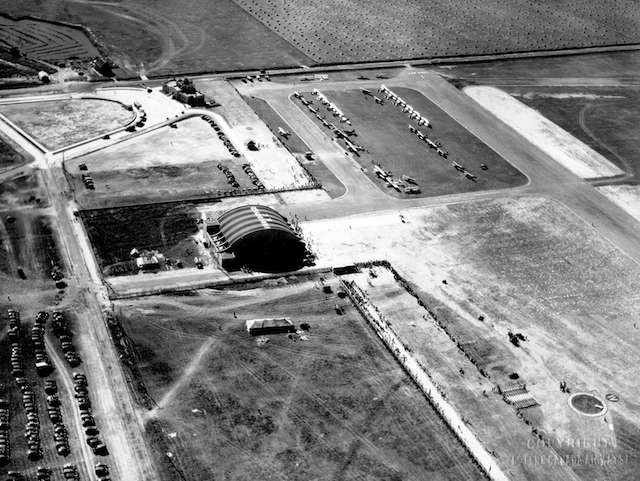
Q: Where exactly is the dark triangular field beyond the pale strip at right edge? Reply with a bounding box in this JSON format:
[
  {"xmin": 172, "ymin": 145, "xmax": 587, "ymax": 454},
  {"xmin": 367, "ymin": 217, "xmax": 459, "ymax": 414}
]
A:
[{"xmin": 506, "ymin": 87, "xmax": 640, "ymax": 180}]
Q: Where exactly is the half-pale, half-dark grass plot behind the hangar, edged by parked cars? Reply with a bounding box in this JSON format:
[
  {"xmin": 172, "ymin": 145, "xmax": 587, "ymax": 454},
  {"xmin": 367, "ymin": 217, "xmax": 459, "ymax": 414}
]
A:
[{"xmin": 65, "ymin": 118, "xmax": 256, "ymax": 209}]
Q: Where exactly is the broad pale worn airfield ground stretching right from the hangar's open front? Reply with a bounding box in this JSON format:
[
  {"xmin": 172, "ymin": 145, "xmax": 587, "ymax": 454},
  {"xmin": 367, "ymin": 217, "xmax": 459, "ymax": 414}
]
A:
[{"xmin": 302, "ymin": 198, "xmax": 640, "ymax": 480}]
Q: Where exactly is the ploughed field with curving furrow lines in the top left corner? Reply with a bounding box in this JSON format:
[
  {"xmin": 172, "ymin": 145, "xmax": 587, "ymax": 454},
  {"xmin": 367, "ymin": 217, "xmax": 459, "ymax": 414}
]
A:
[{"xmin": 0, "ymin": 15, "xmax": 100, "ymax": 64}]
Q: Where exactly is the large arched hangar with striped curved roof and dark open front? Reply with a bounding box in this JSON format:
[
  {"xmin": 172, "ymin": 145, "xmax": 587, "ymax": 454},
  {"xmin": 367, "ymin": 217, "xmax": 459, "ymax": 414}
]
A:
[{"xmin": 208, "ymin": 205, "xmax": 306, "ymax": 272}]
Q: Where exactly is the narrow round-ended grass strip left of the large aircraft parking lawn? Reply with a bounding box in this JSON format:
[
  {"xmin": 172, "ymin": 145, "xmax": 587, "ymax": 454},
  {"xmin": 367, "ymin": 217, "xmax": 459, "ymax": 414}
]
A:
[{"xmin": 244, "ymin": 97, "xmax": 345, "ymax": 197}]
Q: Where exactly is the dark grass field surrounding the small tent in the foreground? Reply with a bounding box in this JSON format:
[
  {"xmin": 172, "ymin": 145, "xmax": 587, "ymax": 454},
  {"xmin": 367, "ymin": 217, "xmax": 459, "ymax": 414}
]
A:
[{"xmin": 116, "ymin": 278, "xmax": 482, "ymax": 480}]
